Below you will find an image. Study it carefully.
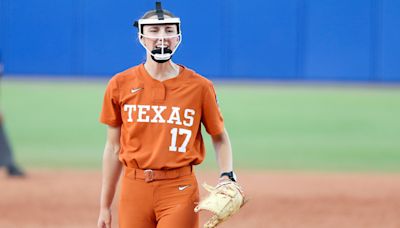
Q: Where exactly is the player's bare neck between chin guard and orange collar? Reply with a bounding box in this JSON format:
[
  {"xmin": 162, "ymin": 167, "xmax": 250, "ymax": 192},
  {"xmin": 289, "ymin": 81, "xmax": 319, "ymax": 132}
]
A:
[{"xmin": 144, "ymin": 58, "xmax": 179, "ymax": 81}]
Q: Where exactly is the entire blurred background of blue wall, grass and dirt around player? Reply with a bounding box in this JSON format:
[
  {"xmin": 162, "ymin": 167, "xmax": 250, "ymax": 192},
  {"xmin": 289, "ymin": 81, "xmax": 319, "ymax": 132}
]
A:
[{"xmin": 0, "ymin": 0, "xmax": 400, "ymax": 228}]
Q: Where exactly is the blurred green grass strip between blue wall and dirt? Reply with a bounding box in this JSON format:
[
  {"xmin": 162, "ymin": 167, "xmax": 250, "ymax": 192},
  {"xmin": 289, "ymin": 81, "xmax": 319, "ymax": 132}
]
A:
[{"xmin": 1, "ymin": 80, "xmax": 400, "ymax": 172}]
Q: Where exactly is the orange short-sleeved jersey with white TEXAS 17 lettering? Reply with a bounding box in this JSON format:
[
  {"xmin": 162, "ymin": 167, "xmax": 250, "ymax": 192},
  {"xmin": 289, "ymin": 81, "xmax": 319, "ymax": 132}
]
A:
[{"xmin": 100, "ymin": 64, "xmax": 224, "ymax": 169}]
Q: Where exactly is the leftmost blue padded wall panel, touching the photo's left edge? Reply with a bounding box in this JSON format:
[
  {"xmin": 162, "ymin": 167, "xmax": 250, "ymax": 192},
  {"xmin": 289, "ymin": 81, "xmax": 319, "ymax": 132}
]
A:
[{"xmin": 2, "ymin": 0, "xmax": 79, "ymax": 75}]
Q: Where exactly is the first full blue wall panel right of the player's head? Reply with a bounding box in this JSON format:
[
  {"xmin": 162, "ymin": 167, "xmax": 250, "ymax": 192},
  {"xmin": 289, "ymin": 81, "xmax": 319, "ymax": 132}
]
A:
[{"xmin": 230, "ymin": 0, "xmax": 297, "ymax": 79}]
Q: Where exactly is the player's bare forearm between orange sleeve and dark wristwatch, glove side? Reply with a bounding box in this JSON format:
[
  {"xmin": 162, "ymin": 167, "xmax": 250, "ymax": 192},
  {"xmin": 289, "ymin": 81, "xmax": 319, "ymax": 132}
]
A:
[{"xmin": 211, "ymin": 129, "xmax": 233, "ymax": 179}]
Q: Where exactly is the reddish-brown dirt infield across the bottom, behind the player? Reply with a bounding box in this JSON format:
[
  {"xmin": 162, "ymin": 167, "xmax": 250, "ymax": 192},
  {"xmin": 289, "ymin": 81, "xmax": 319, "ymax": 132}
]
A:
[{"xmin": 0, "ymin": 170, "xmax": 400, "ymax": 228}]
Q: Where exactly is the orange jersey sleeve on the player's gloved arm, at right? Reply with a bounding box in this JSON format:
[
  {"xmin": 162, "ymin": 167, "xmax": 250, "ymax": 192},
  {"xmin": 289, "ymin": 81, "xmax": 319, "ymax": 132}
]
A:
[{"xmin": 201, "ymin": 82, "xmax": 224, "ymax": 135}]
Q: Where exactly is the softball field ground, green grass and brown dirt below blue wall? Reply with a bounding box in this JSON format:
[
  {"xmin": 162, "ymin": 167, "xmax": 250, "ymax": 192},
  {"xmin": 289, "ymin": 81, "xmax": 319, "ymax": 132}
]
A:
[{"xmin": 0, "ymin": 78, "xmax": 400, "ymax": 228}]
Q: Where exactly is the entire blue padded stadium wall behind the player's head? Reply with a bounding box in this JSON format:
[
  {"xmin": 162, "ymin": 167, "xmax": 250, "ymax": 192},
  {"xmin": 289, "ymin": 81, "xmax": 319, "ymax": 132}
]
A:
[{"xmin": 0, "ymin": 0, "xmax": 400, "ymax": 82}]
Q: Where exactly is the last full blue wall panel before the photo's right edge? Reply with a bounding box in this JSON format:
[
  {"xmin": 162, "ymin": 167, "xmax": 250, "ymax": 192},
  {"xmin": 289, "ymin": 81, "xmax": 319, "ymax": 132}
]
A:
[{"xmin": 305, "ymin": 0, "xmax": 371, "ymax": 80}]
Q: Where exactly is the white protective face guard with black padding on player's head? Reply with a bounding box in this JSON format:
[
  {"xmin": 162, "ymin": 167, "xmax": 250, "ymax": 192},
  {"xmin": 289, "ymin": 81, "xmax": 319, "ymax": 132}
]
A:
[{"xmin": 134, "ymin": 2, "xmax": 182, "ymax": 63}]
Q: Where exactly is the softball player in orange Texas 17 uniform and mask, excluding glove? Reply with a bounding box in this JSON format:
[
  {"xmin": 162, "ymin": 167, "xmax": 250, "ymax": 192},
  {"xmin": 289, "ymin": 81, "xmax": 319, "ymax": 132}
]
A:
[{"xmin": 98, "ymin": 2, "xmax": 235, "ymax": 228}]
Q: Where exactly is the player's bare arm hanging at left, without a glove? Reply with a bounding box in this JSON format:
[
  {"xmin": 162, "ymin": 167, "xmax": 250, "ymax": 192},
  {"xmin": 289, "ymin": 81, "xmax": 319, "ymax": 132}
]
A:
[{"xmin": 97, "ymin": 126, "xmax": 122, "ymax": 228}]
